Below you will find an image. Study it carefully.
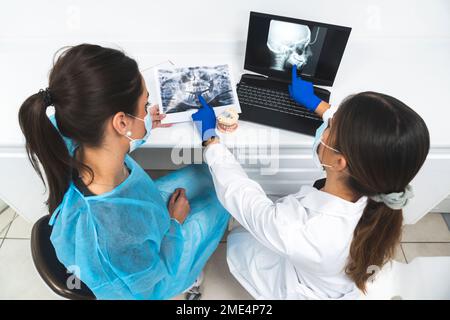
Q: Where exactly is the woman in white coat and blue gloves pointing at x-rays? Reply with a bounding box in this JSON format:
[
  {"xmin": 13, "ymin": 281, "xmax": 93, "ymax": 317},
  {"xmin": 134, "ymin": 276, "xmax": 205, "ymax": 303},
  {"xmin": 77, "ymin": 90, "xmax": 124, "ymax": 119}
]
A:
[{"xmin": 193, "ymin": 67, "xmax": 429, "ymax": 299}]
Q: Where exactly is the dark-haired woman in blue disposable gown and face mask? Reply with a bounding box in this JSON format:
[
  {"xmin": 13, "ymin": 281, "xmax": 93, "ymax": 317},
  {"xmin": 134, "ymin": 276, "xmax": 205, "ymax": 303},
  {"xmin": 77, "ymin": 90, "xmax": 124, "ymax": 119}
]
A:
[{"xmin": 19, "ymin": 44, "xmax": 229, "ymax": 299}]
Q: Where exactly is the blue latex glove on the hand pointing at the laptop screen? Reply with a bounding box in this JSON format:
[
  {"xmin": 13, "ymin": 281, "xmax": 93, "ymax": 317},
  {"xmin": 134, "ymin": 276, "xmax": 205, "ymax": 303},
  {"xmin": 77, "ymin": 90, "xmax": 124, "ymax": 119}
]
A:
[{"xmin": 288, "ymin": 65, "xmax": 322, "ymax": 112}]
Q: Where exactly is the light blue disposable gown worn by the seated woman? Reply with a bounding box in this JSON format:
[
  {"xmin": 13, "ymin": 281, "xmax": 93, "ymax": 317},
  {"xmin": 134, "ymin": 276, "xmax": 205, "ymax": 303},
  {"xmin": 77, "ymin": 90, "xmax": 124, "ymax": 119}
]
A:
[{"xmin": 50, "ymin": 155, "xmax": 229, "ymax": 299}]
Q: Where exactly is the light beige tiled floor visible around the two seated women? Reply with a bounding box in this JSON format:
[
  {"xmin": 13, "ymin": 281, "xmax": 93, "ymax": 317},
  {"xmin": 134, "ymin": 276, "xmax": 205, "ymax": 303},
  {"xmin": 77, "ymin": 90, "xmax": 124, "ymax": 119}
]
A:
[{"xmin": 0, "ymin": 202, "xmax": 450, "ymax": 300}]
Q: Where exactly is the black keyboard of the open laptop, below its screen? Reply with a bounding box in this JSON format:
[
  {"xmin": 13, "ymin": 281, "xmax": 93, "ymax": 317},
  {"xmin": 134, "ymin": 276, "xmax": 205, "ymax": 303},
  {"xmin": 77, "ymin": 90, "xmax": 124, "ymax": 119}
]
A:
[{"xmin": 237, "ymin": 83, "xmax": 321, "ymax": 120}]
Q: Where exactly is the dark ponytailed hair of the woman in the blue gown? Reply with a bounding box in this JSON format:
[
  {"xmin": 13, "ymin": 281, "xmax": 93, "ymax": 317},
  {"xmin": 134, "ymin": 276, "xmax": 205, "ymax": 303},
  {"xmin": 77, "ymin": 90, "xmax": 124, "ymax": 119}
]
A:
[{"xmin": 19, "ymin": 44, "xmax": 143, "ymax": 213}]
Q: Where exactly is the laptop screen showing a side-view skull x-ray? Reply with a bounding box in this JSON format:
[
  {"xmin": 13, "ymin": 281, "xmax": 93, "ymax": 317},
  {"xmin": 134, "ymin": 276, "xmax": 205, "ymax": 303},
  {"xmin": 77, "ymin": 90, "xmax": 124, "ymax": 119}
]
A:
[{"xmin": 244, "ymin": 12, "xmax": 351, "ymax": 86}]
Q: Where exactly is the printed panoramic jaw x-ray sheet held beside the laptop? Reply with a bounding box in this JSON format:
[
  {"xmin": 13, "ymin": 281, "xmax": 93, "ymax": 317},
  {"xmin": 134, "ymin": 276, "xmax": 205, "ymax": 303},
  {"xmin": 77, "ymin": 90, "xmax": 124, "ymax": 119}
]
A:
[{"xmin": 159, "ymin": 65, "xmax": 234, "ymax": 114}]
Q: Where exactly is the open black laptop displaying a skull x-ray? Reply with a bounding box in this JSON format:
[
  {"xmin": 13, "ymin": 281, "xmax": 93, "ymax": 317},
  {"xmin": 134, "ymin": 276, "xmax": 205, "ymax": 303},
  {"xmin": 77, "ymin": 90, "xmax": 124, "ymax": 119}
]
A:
[{"xmin": 237, "ymin": 12, "xmax": 351, "ymax": 135}]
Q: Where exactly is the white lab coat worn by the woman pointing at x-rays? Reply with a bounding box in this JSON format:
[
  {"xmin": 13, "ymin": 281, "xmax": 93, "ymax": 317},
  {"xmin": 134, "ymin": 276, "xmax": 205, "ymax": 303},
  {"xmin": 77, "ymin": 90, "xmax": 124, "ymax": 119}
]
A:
[{"xmin": 204, "ymin": 144, "xmax": 367, "ymax": 299}]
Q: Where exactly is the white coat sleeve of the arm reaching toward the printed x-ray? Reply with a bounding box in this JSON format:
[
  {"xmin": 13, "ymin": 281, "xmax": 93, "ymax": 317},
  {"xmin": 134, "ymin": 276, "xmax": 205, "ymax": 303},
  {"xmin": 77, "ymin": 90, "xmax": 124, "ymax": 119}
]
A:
[{"xmin": 204, "ymin": 138, "xmax": 306, "ymax": 255}]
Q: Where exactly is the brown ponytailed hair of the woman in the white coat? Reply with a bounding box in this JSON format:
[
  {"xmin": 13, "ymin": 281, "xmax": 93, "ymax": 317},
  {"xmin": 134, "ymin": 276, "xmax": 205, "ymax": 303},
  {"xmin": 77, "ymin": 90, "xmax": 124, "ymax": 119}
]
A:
[{"xmin": 330, "ymin": 92, "xmax": 430, "ymax": 292}]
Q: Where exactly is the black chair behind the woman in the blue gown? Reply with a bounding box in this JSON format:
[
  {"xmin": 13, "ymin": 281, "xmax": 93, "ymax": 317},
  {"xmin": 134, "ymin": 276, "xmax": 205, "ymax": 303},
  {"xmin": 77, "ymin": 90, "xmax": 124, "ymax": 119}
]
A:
[{"xmin": 31, "ymin": 215, "xmax": 95, "ymax": 300}]
